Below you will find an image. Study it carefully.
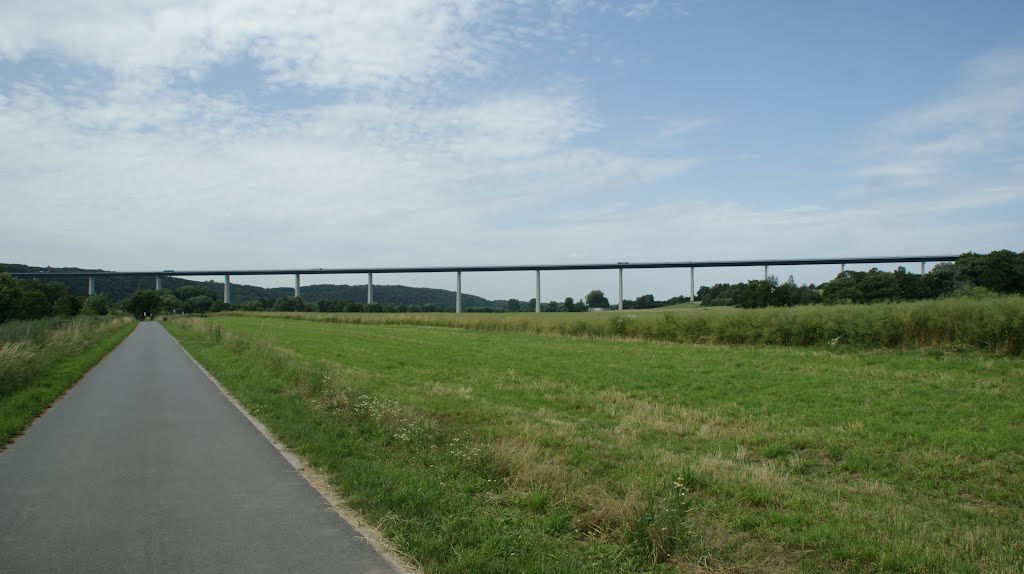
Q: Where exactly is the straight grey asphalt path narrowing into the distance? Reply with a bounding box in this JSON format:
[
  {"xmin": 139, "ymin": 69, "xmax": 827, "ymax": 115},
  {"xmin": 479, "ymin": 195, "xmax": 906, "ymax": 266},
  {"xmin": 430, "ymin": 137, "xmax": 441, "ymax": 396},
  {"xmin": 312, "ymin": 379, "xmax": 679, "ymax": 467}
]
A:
[{"xmin": 0, "ymin": 322, "xmax": 394, "ymax": 574}]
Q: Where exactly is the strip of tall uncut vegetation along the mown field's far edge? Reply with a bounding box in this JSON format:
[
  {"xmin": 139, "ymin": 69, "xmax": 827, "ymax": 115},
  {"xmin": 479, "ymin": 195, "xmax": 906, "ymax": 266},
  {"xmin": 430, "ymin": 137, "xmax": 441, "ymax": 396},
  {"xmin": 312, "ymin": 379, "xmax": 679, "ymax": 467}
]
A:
[{"xmin": 232, "ymin": 296, "xmax": 1024, "ymax": 355}]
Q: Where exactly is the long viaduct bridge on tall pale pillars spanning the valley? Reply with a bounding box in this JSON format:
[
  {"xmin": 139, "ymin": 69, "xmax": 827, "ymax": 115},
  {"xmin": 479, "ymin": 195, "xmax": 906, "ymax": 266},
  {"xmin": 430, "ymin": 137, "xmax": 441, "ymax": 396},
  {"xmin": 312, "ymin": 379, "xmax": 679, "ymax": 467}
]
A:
[{"xmin": 11, "ymin": 255, "xmax": 959, "ymax": 313}]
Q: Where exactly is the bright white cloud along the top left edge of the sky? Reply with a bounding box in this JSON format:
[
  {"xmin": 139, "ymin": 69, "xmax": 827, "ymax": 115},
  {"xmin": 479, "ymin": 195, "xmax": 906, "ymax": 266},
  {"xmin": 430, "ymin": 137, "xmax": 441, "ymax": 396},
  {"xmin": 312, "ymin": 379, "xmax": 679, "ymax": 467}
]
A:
[{"xmin": 0, "ymin": 0, "xmax": 494, "ymax": 88}]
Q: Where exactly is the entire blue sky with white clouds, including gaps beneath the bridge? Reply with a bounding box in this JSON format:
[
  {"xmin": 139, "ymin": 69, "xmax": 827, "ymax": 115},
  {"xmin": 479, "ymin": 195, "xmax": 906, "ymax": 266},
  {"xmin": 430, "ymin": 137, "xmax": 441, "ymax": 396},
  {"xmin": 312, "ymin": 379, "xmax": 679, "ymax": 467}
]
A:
[{"xmin": 0, "ymin": 0, "xmax": 1024, "ymax": 301}]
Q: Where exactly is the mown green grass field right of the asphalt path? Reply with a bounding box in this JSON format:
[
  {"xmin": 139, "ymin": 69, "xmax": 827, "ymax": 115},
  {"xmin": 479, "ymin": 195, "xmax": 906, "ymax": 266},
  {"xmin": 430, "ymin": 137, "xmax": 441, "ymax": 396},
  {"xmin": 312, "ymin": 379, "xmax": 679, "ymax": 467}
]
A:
[{"xmin": 168, "ymin": 310, "xmax": 1024, "ymax": 573}]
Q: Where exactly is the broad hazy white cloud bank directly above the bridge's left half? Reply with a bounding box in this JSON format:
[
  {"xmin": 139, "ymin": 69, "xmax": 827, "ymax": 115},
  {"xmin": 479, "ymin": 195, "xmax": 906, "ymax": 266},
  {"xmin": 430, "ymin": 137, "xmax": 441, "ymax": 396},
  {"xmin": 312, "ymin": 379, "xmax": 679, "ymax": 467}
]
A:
[{"xmin": 0, "ymin": 75, "xmax": 693, "ymax": 276}]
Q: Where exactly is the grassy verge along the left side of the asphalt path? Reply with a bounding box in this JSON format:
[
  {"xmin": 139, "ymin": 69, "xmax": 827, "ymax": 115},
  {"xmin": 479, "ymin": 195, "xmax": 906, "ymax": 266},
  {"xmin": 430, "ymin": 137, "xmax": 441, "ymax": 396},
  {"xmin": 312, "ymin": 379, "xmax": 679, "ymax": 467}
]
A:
[{"xmin": 0, "ymin": 317, "xmax": 135, "ymax": 447}]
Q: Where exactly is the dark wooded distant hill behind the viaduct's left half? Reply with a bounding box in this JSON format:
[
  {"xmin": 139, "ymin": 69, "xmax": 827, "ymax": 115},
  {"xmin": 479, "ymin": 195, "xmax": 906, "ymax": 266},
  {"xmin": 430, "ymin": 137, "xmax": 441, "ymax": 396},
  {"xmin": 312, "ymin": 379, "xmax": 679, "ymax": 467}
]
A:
[{"xmin": 0, "ymin": 263, "xmax": 505, "ymax": 309}]
